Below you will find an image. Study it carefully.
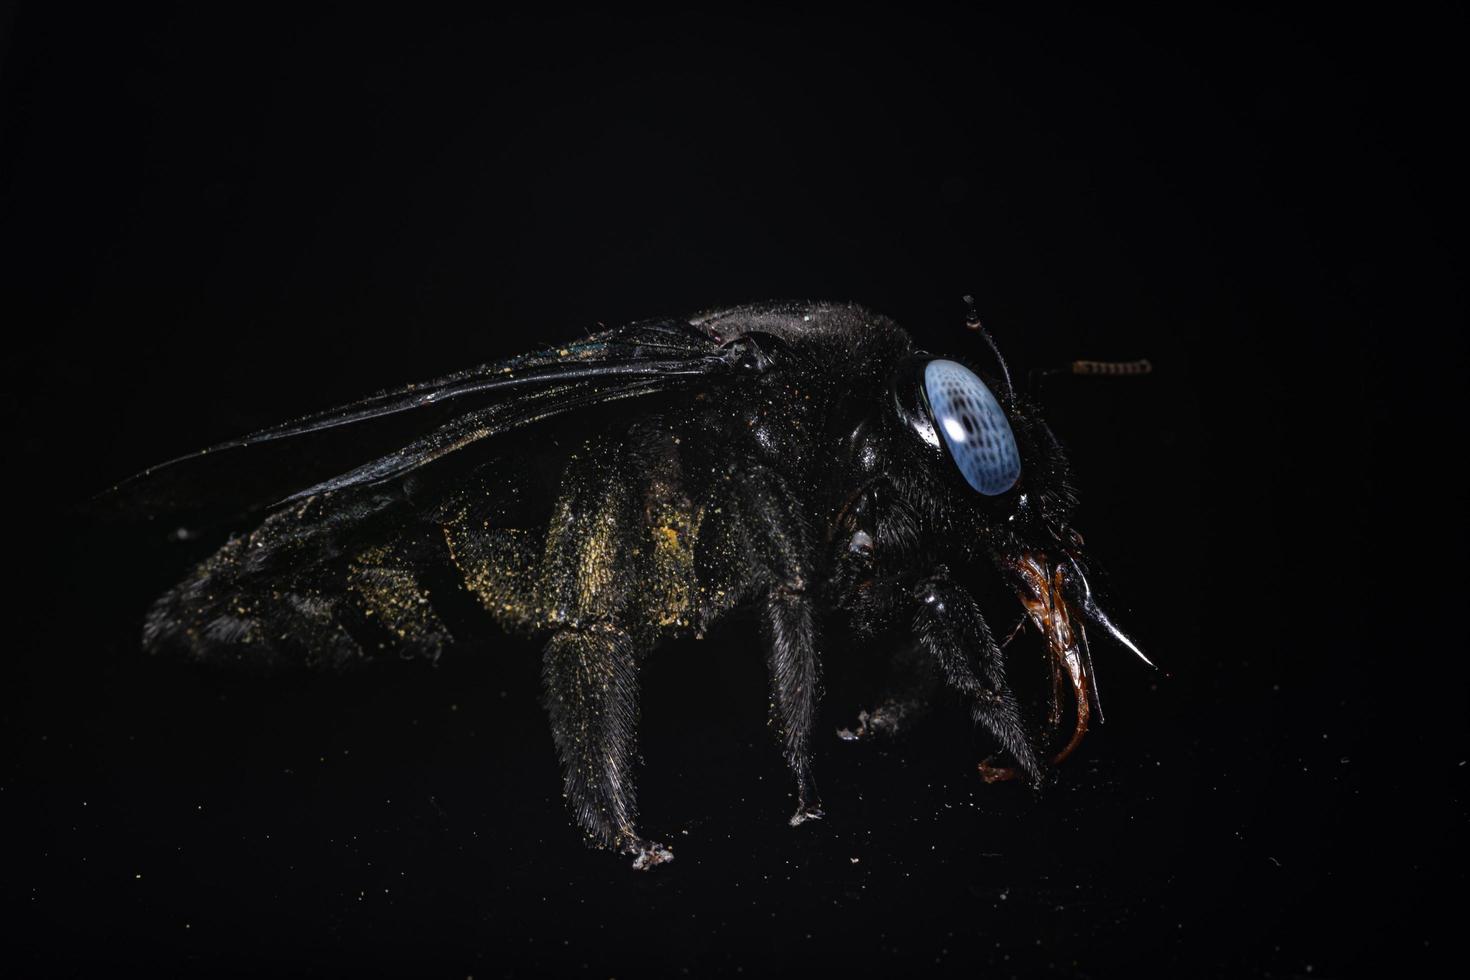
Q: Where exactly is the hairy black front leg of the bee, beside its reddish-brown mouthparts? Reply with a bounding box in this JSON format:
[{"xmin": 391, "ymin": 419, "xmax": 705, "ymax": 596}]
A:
[{"xmin": 914, "ymin": 573, "xmax": 1042, "ymax": 788}]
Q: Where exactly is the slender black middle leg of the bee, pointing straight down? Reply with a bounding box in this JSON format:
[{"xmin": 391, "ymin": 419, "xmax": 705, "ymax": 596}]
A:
[{"xmin": 741, "ymin": 467, "xmax": 823, "ymax": 827}]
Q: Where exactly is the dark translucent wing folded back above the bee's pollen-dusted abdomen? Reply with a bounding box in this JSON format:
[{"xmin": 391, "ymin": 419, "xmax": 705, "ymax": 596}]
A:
[{"xmin": 94, "ymin": 320, "xmax": 769, "ymax": 523}]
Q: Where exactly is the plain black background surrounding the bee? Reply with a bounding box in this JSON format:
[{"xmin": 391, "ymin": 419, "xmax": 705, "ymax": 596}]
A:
[{"xmin": 0, "ymin": 4, "xmax": 1467, "ymax": 976}]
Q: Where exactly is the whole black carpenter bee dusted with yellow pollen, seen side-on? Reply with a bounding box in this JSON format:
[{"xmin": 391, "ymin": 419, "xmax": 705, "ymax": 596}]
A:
[{"xmin": 109, "ymin": 303, "xmax": 1142, "ymax": 868}]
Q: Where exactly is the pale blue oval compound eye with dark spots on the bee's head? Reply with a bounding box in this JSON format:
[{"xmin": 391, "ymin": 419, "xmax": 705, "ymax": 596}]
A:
[{"xmin": 923, "ymin": 360, "xmax": 1020, "ymax": 497}]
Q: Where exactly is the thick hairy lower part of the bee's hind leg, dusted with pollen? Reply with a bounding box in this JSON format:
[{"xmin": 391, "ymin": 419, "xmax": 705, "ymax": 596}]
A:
[{"xmin": 541, "ymin": 623, "xmax": 673, "ymax": 870}]
